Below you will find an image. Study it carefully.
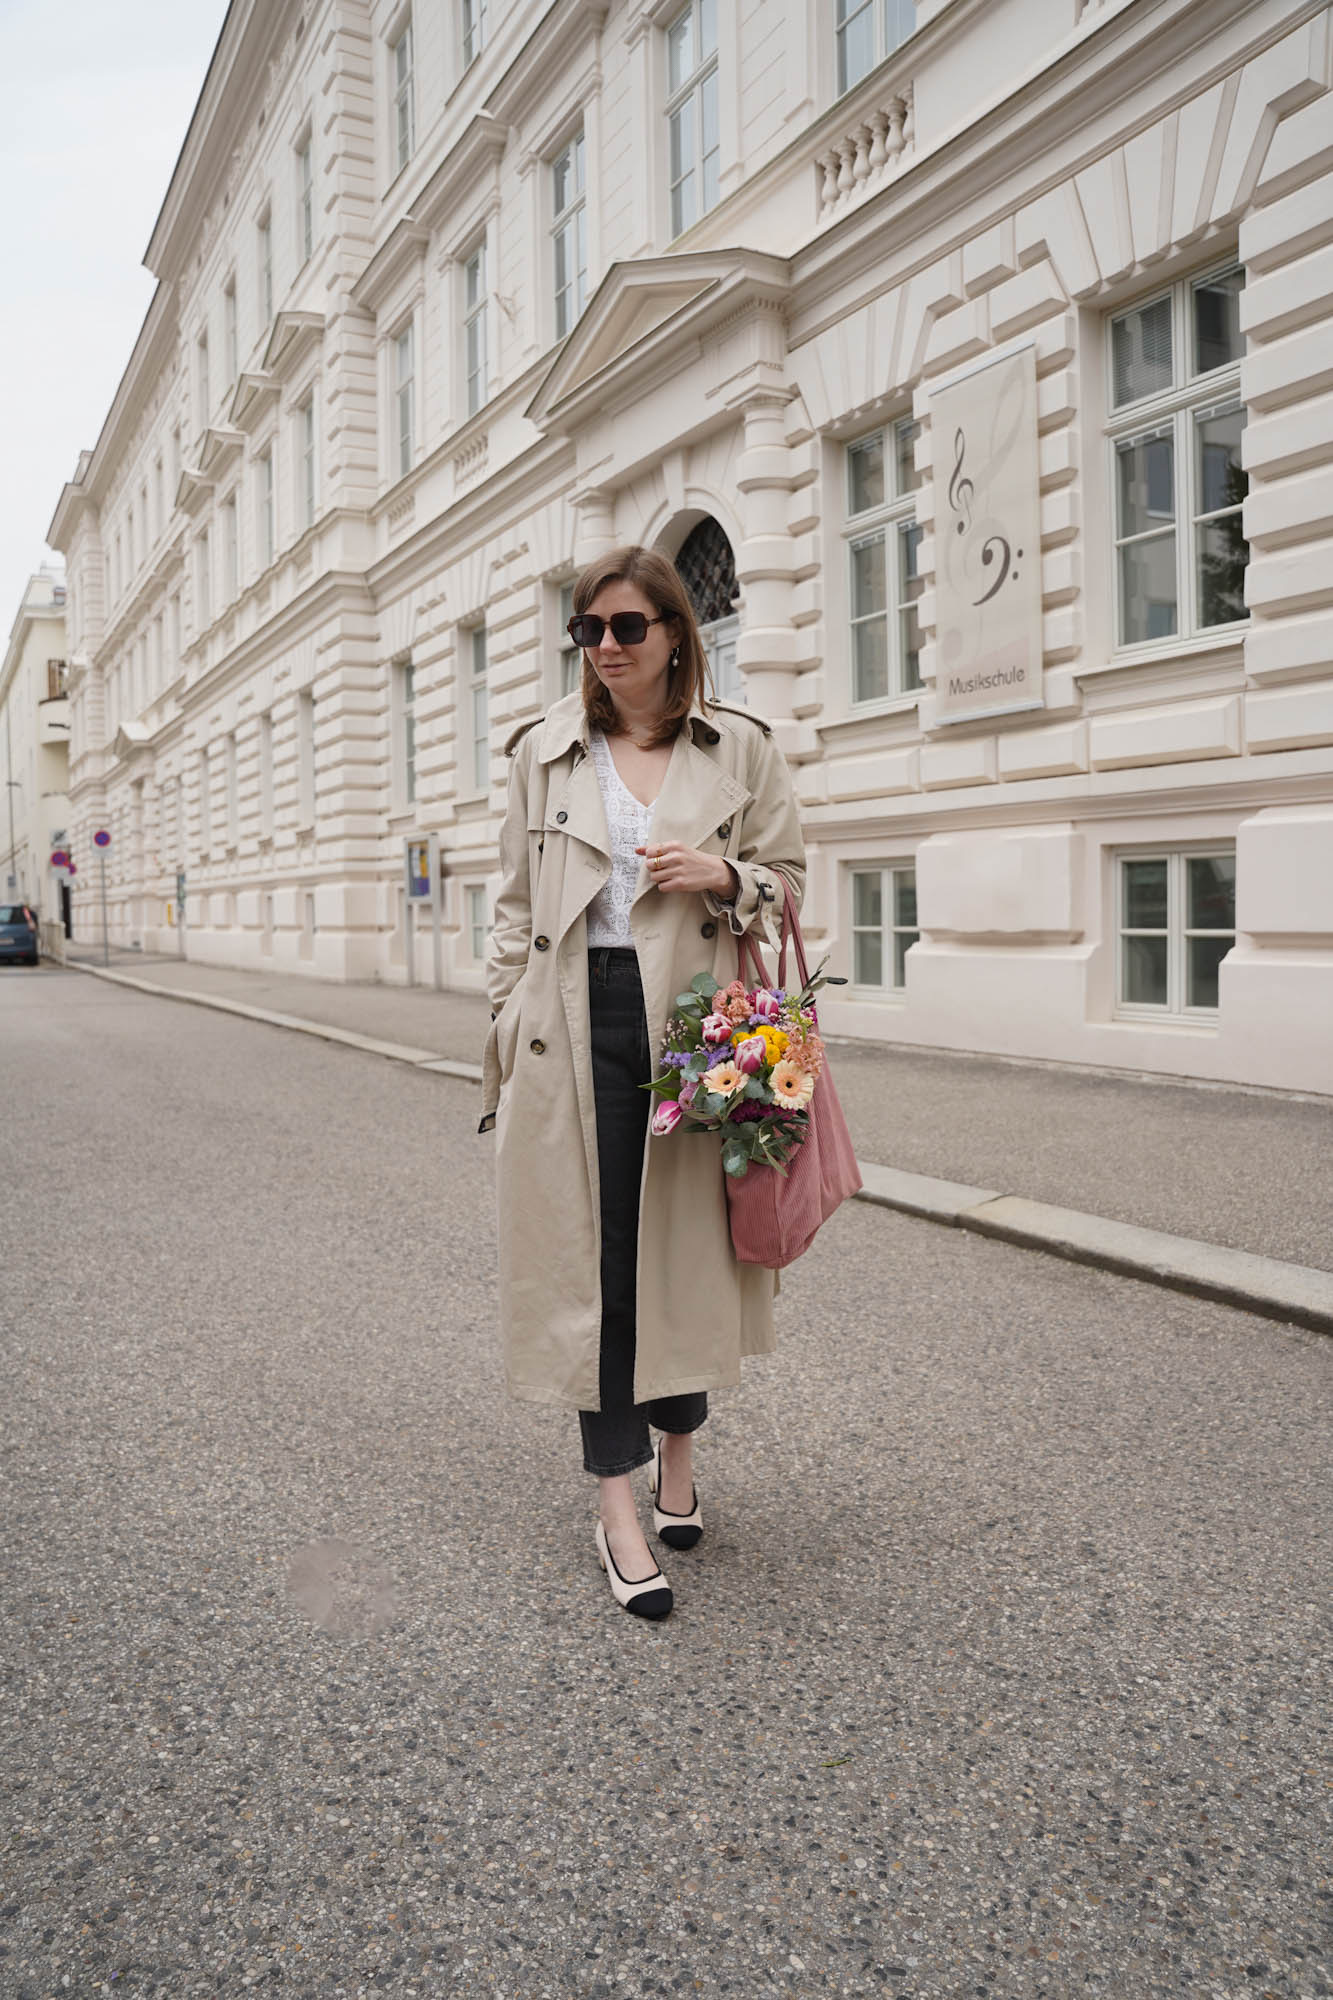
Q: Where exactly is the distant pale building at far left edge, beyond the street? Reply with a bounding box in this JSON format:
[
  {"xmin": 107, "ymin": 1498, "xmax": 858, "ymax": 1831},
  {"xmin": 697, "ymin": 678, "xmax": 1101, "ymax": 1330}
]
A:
[{"xmin": 0, "ymin": 570, "xmax": 70, "ymax": 928}]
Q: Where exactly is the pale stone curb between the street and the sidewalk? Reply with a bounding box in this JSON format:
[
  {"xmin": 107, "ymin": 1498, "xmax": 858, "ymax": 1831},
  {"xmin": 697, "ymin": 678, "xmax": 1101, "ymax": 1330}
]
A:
[{"xmin": 70, "ymin": 960, "xmax": 1333, "ymax": 1334}]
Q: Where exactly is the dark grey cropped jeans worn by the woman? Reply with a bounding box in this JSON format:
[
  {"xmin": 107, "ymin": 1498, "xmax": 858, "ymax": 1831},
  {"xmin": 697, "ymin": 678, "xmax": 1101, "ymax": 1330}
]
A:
[{"xmin": 578, "ymin": 946, "xmax": 709, "ymax": 1478}]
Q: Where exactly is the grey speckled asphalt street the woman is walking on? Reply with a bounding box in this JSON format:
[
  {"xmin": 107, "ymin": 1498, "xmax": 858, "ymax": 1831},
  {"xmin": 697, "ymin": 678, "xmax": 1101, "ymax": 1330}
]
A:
[{"xmin": 0, "ymin": 968, "xmax": 1333, "ymax": 2000}]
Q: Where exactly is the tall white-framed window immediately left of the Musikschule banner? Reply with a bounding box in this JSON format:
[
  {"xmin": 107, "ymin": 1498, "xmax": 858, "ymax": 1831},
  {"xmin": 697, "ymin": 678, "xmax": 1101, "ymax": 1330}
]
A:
[{"xmin": 845, "ymin": 418, "xmax": 921, "ymax": 702}]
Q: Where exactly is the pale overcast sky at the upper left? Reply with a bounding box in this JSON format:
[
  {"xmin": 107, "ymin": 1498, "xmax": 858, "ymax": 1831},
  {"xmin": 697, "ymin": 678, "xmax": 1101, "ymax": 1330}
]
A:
[{"xmin": 0, "ymin": 0, "xmax": 226, "ymax": 628}]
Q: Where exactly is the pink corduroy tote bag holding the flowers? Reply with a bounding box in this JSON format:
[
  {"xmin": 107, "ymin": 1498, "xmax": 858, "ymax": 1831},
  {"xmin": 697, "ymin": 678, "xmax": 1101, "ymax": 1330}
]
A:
[{"xmin": 723, "ymin": 876, "xmax": 861, "ymax": 1270}]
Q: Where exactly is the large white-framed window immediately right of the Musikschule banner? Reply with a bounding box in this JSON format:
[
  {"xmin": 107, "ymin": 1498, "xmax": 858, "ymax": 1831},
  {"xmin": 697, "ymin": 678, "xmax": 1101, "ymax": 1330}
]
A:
[{"xmin": 1109, "ymin": 268, "xmax": 1249, "ymax": 646}]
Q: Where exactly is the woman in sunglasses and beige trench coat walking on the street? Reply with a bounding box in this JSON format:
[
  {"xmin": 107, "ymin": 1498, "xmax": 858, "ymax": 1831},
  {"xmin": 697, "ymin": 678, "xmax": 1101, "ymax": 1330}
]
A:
[{"xmin": 480, "ymin": 548, "xmax": 805, "ymax": 1618}]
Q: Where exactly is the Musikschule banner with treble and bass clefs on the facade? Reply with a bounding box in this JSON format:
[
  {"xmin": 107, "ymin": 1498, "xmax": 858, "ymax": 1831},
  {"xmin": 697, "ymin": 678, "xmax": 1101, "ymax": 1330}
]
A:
[{"xmin": 931, "ymin": 346, "xmax": 1043, "ymax": 722}]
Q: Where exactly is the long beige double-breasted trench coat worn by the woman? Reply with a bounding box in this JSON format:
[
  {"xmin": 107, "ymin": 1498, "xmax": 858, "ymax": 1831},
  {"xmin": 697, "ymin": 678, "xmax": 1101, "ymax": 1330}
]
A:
[{"xmin": 480, "ymin": 690, "xmax": 805, "ymax": 1410}]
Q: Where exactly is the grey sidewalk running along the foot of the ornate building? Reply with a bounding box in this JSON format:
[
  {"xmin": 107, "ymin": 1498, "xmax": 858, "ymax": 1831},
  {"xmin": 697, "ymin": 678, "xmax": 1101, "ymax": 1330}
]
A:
[{"xmin": 59, "ymin": 946, "xmax": 1333, "ymax": 1324}]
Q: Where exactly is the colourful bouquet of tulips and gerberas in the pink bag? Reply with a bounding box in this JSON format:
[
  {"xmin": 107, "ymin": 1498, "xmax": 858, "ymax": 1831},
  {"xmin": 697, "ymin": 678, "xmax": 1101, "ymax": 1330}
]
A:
[{"xmin": 644, "ymin": 962, "xmax": 841, "ymax": 1180}]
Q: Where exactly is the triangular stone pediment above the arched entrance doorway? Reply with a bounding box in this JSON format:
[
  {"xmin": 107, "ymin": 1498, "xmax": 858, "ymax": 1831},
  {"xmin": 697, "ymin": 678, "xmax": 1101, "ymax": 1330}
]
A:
[{"xmin": 526, "ymin": 250, "xmax": 789, "ymax": 430}]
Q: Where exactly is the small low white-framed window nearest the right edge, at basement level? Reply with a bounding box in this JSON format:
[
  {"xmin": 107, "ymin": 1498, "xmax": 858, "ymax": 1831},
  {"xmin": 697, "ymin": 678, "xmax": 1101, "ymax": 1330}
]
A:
[{"xmin": 1117, "ymin": 848, "xmax": 1235, "ymax": 1018}]
